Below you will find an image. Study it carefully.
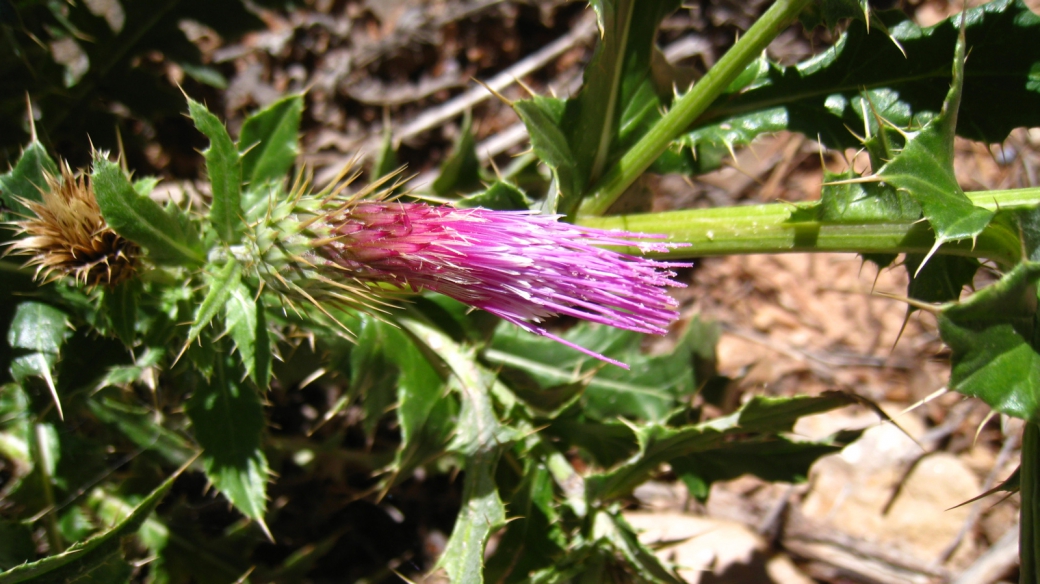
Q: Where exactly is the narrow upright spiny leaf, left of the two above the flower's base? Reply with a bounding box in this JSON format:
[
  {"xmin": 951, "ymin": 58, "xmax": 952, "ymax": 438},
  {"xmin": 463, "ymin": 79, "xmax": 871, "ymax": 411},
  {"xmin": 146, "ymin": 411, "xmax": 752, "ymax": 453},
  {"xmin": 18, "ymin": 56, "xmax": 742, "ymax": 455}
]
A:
[{"xmin": 188, "ymin": 99, "xmax": 242, "ymax": 243}]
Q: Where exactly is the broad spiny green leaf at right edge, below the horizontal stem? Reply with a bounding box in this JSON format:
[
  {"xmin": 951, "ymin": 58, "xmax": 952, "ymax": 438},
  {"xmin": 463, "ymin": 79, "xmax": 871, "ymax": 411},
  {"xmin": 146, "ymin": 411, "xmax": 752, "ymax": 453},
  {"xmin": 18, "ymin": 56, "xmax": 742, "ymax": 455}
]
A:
[{"xmin": 939, "ymin": 262, "xmax": 1040, "ymax": 423}]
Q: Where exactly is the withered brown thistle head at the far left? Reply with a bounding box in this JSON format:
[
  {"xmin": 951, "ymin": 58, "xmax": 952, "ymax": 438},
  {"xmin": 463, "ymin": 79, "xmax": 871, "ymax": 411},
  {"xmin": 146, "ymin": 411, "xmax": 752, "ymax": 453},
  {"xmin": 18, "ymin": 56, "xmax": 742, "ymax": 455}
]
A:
[{"xmin": 7, "ymin": 162, "xmax": 140, "ymax": 288}]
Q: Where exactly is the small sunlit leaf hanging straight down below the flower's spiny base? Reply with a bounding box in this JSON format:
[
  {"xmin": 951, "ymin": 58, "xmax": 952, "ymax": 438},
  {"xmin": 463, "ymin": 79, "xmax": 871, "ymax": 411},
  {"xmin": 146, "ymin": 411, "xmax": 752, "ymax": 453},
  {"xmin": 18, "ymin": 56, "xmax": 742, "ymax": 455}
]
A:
[{"xmin": 224, "ymin": 282, "xmax": 271, "ymax": 391}]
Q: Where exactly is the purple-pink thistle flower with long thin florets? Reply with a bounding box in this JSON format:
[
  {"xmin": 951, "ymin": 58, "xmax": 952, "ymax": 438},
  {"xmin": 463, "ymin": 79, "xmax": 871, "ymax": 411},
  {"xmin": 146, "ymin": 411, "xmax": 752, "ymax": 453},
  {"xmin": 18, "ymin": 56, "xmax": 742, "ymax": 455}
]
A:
[{"xmin": 319, "ymin": 202, "xmax": 690, "ymax": 369}]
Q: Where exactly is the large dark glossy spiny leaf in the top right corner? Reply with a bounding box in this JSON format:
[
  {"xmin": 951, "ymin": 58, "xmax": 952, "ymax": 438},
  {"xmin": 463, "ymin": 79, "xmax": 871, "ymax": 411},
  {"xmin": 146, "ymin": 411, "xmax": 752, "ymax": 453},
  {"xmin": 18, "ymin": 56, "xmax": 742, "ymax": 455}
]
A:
[{"xmin": 680, "ymin": 0, "xmax": 1040, "ymax": 154}]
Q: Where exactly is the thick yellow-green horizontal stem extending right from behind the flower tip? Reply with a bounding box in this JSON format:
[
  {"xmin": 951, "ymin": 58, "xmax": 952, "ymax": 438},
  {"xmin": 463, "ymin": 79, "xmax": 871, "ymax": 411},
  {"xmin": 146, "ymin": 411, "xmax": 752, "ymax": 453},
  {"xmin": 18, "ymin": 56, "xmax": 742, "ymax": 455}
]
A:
[{"xmin": 577, "ymin": 188, "xmax": 1040, "ymax": 265}]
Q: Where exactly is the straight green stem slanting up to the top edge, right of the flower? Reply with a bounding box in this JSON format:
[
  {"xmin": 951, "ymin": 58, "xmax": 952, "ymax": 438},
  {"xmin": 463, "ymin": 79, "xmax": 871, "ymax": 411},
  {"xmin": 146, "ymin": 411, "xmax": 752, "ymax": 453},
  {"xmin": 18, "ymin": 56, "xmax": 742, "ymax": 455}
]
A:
[{"xmin": 578, "ymin": 0, "xmax": 810, "ymax": 215}]
